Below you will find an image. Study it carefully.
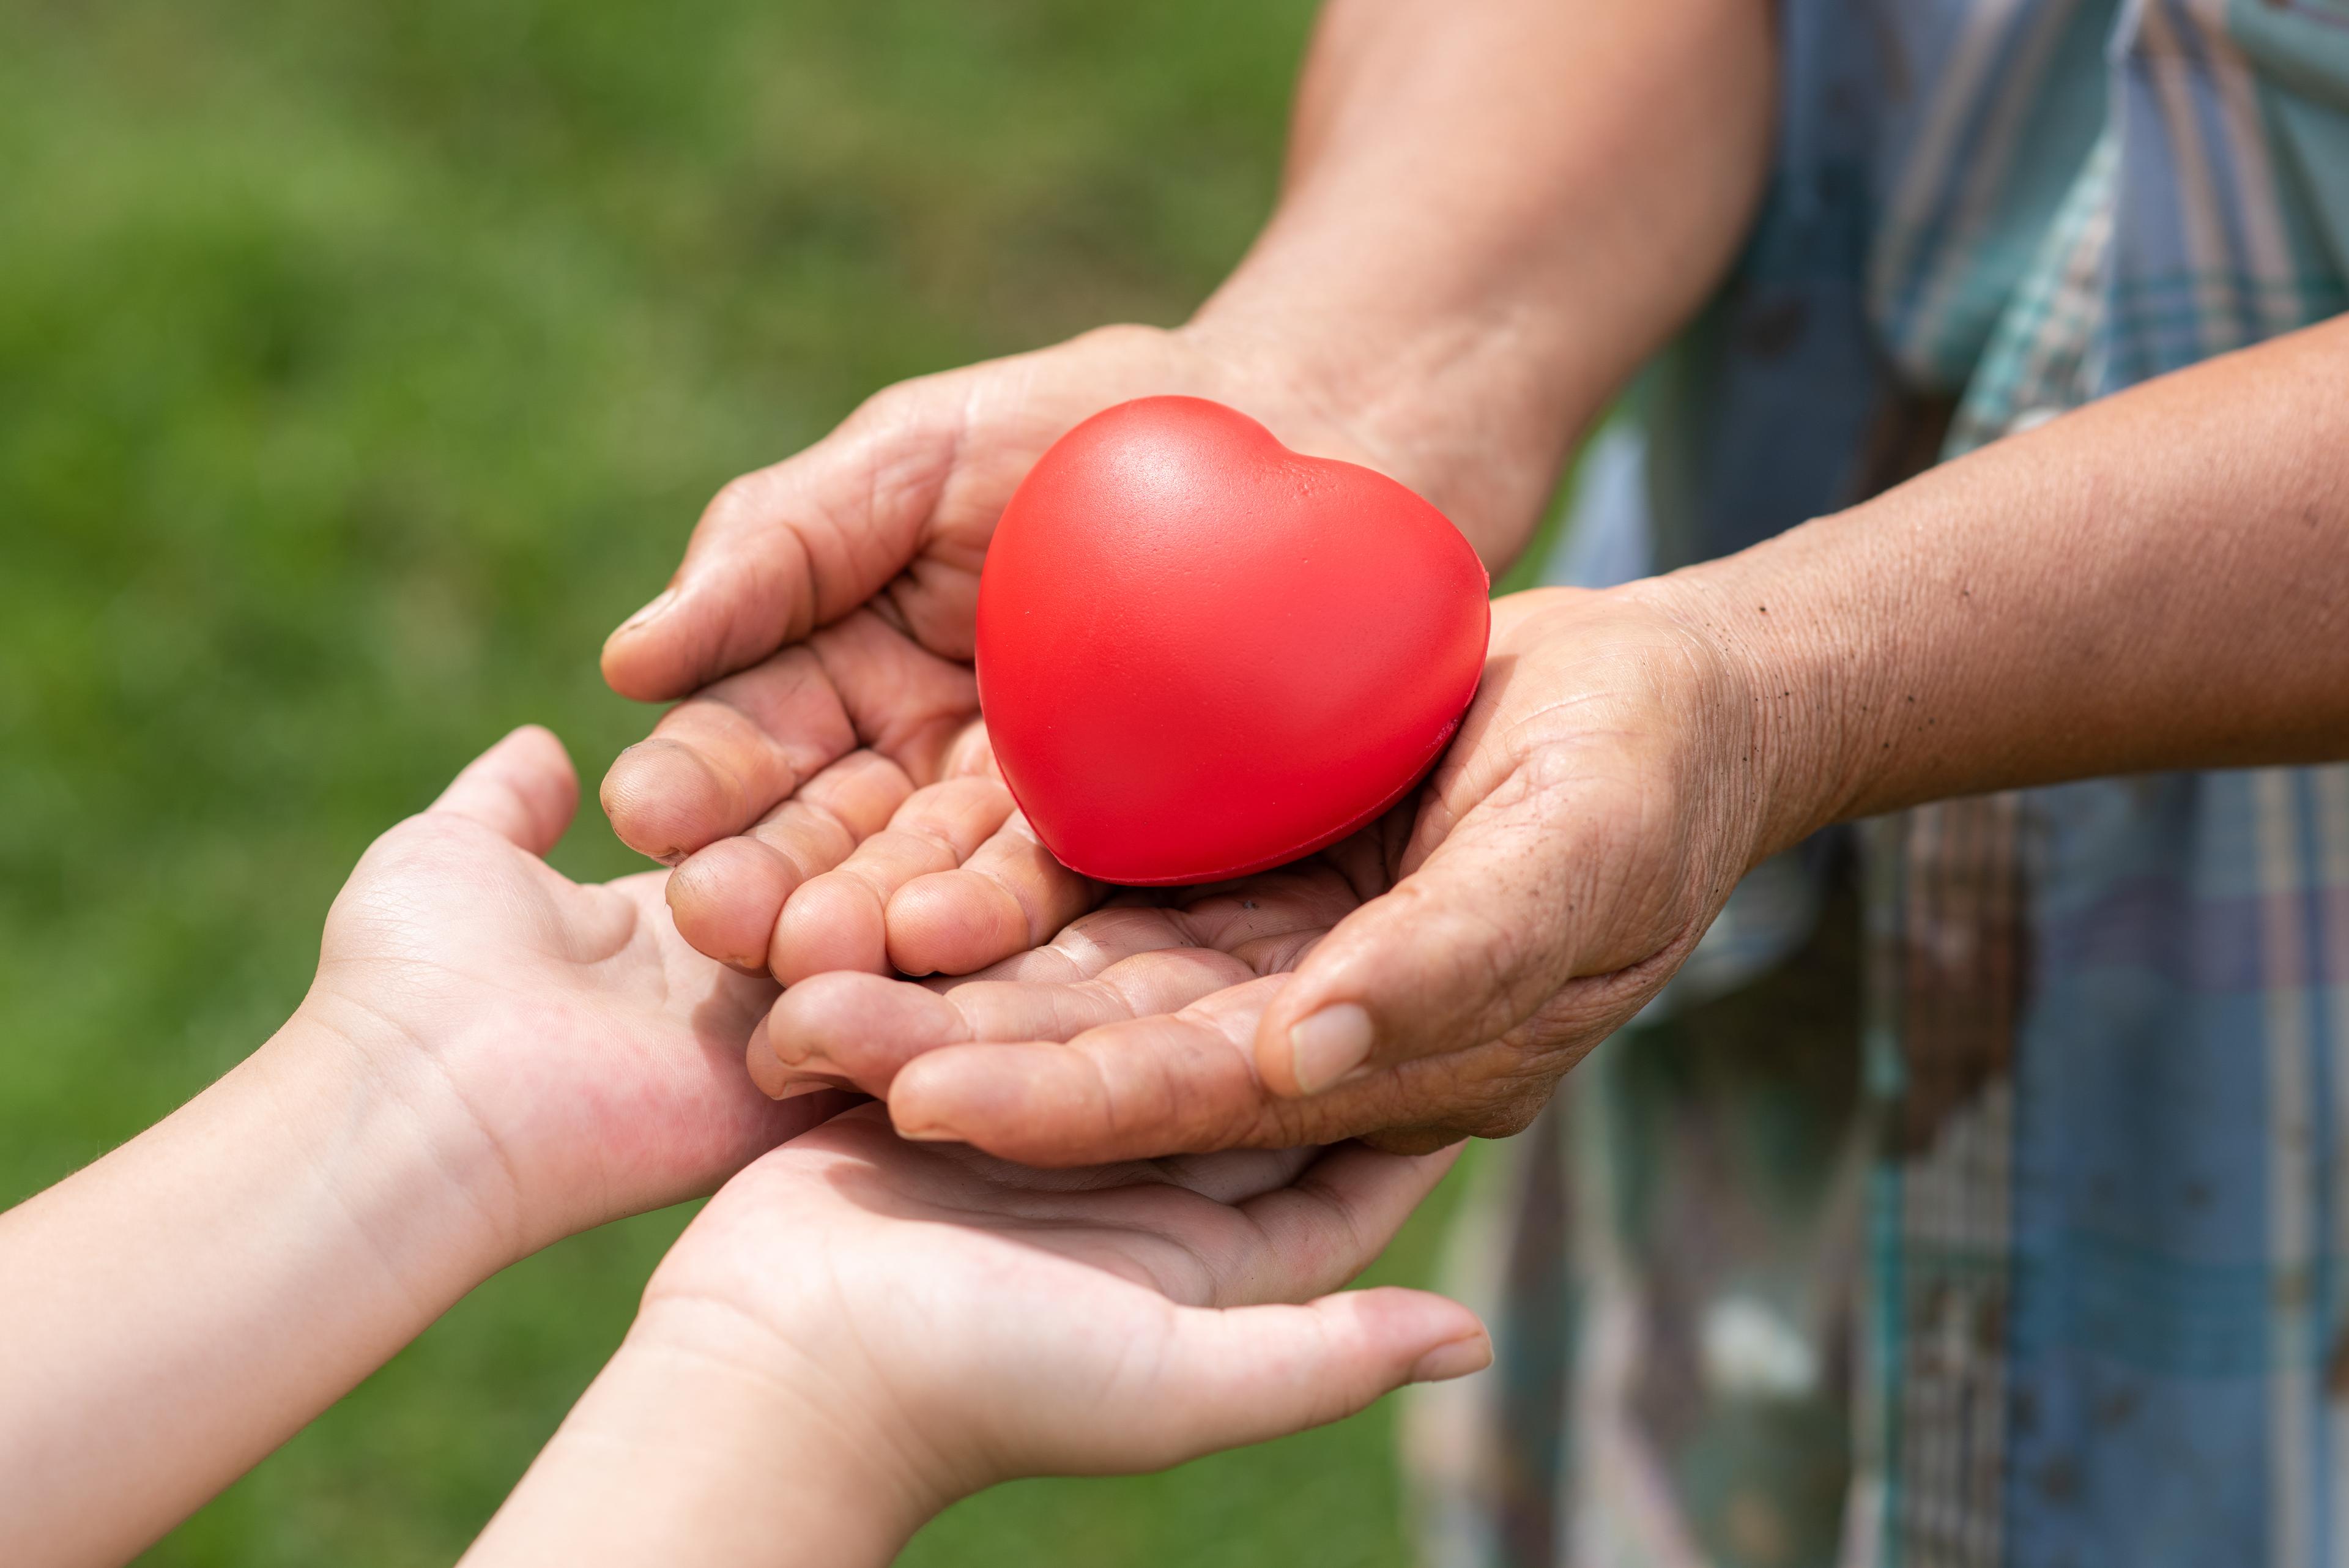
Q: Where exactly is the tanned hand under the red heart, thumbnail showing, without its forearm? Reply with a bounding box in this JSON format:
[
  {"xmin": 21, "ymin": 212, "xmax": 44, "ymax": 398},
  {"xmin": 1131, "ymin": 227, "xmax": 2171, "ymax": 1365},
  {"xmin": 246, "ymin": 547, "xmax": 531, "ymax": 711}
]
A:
[{"xmin": 749, "ymin": 590, "xmax": 1773, "ymax": 1164}]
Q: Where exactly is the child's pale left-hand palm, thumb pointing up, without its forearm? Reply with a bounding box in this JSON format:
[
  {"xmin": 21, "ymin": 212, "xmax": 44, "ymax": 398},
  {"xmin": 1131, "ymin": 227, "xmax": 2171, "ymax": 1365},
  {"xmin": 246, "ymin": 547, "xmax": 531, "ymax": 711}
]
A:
[{"xmin": 299, "ymin": 729, "xmax": 844, "ymax": 1255}]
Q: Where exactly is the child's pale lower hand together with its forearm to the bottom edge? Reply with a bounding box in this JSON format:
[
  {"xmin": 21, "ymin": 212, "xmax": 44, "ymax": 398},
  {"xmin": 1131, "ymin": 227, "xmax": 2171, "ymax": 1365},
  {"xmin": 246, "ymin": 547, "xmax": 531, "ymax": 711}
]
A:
[{"xmin": 470, "ymin": 1105, "xmax": 1490, "ymax": 1563}]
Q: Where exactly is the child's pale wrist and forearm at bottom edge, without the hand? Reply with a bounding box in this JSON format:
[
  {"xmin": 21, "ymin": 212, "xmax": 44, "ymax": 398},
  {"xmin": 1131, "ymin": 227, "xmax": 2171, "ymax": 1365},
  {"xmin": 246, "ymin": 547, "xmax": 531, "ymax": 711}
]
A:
[{"xmin": 465, "ymin": 1300, "xmax": 951, "ymax": 1568}]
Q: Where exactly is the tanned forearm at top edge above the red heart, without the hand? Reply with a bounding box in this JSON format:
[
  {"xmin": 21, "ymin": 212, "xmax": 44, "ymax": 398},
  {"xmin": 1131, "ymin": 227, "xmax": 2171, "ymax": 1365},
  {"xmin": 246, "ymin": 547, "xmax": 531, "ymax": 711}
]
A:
[{"xmin": 1193, "ymin": 0, "xmax": 1776, "ymax": 562}]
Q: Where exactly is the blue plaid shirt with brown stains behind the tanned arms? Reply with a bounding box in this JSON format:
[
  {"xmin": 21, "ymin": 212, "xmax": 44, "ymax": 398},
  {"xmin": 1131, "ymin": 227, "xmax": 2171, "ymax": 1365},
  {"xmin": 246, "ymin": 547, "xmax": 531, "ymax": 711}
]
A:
[{"xmin": 1412, "ymin": 0, "xmax": 2349, "ymax": 1568}]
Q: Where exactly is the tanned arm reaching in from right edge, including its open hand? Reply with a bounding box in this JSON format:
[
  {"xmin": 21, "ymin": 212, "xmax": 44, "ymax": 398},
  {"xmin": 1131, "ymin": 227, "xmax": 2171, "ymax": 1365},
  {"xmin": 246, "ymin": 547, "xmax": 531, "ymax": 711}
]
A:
[{"xmin": 754, "ymin": 320, "xmax": 2349, "ymax": 1161}]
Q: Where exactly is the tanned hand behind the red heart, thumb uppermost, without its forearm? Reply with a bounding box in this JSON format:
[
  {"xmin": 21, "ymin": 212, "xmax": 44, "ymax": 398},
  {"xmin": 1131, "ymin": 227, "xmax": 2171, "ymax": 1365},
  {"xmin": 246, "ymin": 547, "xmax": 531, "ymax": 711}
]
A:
[{"xmin": 604, "ymin": 327, "xmax": 1426, "ymax": 976}]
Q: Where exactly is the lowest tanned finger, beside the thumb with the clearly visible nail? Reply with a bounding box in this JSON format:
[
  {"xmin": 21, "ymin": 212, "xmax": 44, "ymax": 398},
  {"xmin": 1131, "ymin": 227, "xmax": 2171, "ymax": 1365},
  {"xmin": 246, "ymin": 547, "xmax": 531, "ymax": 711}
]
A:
[{"xmin": 888, "ymin": 976, "xmax": 1313, "ymax": 1166}]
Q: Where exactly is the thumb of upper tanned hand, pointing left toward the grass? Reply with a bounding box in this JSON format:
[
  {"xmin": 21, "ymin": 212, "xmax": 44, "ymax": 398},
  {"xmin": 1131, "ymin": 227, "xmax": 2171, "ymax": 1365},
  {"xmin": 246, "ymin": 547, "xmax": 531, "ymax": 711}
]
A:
[{"xmin": 604, "ymin": 383, "xmax": 977, "ymax": 700}]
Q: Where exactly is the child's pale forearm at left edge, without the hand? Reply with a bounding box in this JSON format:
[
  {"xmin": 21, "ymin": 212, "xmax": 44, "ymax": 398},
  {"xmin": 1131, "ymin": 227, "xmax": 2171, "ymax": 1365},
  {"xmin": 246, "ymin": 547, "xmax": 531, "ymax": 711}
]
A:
[{"xmin": 0, "ymin": 1023, "xmax": 503, "ymax": 1568}]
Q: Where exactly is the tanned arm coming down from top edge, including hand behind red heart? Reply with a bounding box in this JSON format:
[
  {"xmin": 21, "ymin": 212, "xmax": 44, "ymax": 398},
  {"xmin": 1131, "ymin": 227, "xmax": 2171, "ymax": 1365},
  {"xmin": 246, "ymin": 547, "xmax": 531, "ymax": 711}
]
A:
[{"xmin": 604, "ymin": 0, "xmax": 1776, "ymax": 980}]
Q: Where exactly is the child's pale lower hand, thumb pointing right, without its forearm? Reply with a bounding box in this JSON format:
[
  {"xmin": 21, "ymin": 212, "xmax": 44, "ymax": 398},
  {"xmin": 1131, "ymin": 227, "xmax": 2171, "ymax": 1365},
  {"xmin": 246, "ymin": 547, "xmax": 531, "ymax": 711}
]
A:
[{"xmin": 627, "ymin": 1107, "xmax": 1491, "ymax": 1512}]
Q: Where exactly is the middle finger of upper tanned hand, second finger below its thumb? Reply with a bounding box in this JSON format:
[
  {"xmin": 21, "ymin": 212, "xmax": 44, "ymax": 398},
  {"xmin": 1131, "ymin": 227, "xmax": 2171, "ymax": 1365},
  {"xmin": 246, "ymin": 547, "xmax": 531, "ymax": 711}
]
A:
[{"xmin": 667, "ymin": 750, "xmax": 914, "ymax": 971}]
